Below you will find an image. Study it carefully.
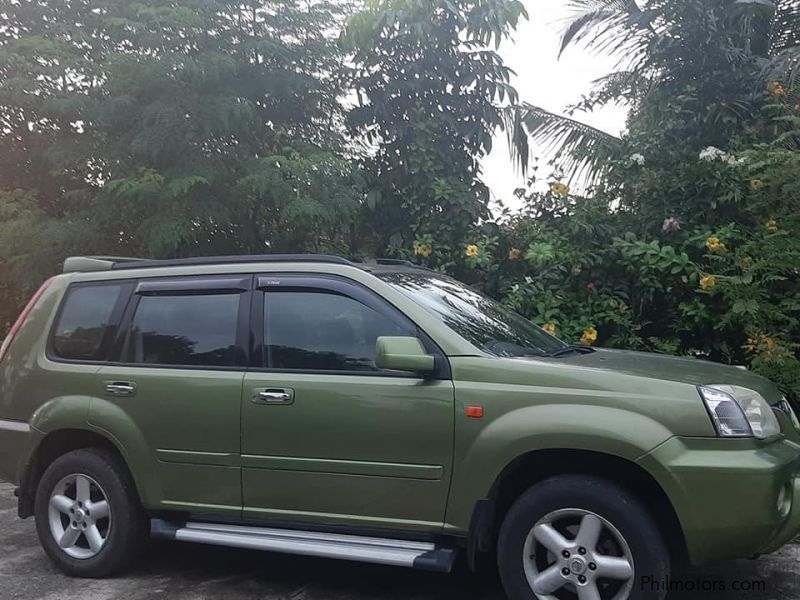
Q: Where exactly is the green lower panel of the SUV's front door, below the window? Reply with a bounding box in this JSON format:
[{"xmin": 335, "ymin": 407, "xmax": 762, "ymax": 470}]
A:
[{"xmin": 242, "ymin": 373, "xmax": 453, "ymax": 528}]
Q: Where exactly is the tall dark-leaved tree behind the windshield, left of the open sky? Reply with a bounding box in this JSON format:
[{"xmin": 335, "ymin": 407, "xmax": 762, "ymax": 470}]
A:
[{"xmin": 342, "ymin": 0, "xmax": 526, "ymax": 252}]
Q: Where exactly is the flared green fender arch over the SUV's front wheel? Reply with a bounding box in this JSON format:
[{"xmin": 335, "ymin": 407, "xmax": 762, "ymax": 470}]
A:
[{"xmin": 447, "ymin": 403, "xmax": 672, "ymax": 532}]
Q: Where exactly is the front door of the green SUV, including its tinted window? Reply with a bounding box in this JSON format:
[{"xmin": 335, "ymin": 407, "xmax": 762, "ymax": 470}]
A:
[{"xmin": 242, "ymin": 275, "xmax": 454, "ymax": 531}]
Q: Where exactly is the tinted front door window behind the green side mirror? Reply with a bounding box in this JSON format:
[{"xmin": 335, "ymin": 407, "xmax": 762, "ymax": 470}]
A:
[{"xmin": 264, "ymin": 292, "xmax": 416, "ymax": 371}]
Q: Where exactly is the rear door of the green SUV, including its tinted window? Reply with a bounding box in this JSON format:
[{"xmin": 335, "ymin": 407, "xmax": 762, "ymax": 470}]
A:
[{"xmin": 98, "ymin": 275, "xmax": 252, "ymax": 516}]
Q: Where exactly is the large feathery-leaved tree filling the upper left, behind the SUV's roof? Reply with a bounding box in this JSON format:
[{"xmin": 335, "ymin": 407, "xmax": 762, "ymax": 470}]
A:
[{"xmin": 0, "ymin": 0, "xmax": 361, "ymax": 326}]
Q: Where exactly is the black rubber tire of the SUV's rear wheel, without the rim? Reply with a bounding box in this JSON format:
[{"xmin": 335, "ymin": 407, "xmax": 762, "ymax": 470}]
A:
[{"xmin": 34, "ymin": 448, "xmax": 150, "ymax": 578}]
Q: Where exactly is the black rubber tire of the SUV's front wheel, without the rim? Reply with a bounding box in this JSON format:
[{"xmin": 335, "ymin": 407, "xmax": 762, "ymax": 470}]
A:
[{"xmin": 497, "ymin": 475, "xmax": 670, "ymax": 600}]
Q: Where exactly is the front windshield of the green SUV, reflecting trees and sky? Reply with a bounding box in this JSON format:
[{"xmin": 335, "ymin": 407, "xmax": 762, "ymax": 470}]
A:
[{"xmin": 377, "ymin": 272, "xmax": 569, "ymax": 357}]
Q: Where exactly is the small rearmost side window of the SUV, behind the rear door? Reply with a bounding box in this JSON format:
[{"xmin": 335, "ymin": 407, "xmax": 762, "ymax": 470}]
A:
[{"xmin": 53, "ymin": 285, "xmax": 122, "ymax": 360}]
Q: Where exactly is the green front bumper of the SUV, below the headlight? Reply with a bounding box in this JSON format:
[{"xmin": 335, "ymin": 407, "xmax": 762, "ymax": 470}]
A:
[{"xmin": 639, "ymin": 437, "xmax": 800, "ymax": 565}]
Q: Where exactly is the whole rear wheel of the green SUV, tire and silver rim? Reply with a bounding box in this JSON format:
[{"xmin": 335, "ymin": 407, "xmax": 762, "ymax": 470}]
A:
[{"xmin": 35, "ymin": 448, "xmax": 149, "ymax": 577}]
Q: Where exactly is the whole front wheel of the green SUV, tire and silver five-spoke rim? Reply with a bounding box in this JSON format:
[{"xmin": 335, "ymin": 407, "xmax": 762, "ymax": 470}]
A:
[{"xmin": 498, "ymin": 475, "xmax": 670, "ymax": 600}]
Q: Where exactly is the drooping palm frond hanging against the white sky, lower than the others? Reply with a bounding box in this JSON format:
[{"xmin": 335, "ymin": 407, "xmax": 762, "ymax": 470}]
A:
[{"xmin": 503, "ymin": 103, "xmax": 619, "ymax": 180}]
